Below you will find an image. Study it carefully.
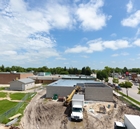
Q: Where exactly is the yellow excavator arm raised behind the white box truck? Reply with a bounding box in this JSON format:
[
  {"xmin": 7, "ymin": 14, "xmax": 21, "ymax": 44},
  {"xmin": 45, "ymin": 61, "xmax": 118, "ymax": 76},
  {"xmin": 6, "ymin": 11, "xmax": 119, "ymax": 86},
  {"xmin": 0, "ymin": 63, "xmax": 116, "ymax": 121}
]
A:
[{"xmin": 64, "ymin": 86, "xmax": 80, "ymax": 106}]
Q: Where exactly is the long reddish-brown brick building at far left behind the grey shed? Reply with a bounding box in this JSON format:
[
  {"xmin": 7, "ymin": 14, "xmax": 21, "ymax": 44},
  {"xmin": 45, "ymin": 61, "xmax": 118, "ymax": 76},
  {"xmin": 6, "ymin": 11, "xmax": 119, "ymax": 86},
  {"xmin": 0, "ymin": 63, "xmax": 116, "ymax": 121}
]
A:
[{"xmin": 0, "ymin": 71, "xmax": 33, "ymax": 84}]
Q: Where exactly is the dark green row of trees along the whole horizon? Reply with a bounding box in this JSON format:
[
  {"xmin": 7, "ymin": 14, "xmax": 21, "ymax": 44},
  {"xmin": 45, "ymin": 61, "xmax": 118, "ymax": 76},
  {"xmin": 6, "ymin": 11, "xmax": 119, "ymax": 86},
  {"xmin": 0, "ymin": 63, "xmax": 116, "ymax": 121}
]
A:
[{"xmin": 0, "ymin": 65, "xmax": 140, "ymax": 75}]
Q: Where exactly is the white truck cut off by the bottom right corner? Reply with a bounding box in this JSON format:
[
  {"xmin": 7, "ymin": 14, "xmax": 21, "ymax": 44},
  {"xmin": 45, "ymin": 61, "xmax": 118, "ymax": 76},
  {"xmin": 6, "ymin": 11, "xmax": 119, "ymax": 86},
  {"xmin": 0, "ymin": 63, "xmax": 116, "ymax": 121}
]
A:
[{"xmin": 114, "ymin": 114, "xmax": 140, "ymax": 129}]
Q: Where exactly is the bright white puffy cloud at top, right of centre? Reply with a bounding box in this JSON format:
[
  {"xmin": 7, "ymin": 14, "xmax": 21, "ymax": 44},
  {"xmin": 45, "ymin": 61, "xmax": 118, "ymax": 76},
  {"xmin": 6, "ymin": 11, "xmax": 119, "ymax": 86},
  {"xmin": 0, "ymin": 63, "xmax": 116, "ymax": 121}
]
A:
[{"xmin": 76, "ymin": 0, "xmax": 110, "ymax": 30}]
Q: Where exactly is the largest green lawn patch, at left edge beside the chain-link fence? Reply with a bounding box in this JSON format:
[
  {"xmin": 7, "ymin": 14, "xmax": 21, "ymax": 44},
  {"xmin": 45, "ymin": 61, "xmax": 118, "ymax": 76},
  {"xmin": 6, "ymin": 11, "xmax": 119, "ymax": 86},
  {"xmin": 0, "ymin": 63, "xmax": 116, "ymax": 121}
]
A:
[{"xmin": 0, "ymin": 100, "xmax": 17, "ymax": 114}]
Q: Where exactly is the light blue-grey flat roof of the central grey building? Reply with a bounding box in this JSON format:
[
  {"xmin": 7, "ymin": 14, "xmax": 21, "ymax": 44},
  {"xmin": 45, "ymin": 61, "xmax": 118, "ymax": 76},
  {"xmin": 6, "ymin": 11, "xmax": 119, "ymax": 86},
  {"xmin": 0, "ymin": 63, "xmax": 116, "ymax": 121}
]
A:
[{"xmin": 48, "ymin": 79, "xmax": 101, "ymax": 87}]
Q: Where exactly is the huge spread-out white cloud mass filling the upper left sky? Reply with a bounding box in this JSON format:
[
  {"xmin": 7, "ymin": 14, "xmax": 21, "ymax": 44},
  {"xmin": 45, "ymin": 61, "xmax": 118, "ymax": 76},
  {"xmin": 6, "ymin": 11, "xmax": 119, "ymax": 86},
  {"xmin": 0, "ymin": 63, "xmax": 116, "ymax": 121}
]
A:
[{"xmin": 0, "ymin": 0, "xmax": 79, "ymax": 63}]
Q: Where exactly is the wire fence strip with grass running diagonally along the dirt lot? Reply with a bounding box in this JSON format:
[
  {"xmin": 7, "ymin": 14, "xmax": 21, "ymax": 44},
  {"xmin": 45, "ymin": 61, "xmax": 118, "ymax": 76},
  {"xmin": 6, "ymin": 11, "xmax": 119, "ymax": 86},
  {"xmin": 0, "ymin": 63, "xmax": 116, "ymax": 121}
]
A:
[{"xmin": 0, "ymin": 93, "xmax": 35, "ymax": 123}]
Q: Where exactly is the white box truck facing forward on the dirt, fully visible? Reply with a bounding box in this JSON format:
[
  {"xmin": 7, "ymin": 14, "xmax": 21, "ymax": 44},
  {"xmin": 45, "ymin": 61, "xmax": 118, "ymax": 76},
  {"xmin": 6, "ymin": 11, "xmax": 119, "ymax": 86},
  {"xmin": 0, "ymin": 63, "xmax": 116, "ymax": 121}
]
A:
[{"xmin": 71, "ymin": 94, "xmax": 84, "ymax": 120}]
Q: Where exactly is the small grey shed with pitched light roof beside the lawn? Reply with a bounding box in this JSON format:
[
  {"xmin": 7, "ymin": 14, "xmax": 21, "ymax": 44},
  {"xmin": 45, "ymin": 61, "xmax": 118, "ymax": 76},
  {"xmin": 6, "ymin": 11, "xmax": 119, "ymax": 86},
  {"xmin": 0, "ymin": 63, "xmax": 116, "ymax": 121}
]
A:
[{"xmin": 10, "ymin": 78, "xmax": 35, "ymax": 91}]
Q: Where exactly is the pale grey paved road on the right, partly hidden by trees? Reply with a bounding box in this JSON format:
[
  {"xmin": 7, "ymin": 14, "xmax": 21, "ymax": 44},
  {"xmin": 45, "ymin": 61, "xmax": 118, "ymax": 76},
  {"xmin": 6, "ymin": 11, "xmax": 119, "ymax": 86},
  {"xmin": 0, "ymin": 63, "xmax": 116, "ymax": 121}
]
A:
[{"xmin": 109, "ymin": 78, "xmax": 140, "ymax": 102}]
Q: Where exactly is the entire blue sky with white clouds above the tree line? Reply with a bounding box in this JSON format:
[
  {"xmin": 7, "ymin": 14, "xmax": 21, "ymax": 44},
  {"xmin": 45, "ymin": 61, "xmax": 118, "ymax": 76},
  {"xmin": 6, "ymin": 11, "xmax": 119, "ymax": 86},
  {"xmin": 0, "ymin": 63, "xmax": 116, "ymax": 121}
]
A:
[{"xmin": 0, "ymin": 0, "xmax": 140, "ymax": 69}]
